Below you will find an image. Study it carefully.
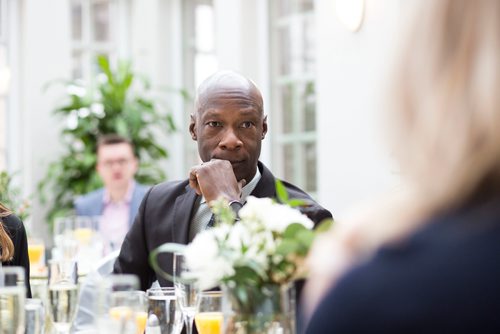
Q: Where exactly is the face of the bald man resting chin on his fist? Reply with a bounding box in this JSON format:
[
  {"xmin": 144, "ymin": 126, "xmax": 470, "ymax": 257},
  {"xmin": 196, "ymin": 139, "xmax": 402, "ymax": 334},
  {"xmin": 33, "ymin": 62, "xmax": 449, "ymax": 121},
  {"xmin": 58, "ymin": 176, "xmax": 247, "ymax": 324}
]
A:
[{"xmin": 189, "ymin": 91, "xmax": 267, "ymax": 182}]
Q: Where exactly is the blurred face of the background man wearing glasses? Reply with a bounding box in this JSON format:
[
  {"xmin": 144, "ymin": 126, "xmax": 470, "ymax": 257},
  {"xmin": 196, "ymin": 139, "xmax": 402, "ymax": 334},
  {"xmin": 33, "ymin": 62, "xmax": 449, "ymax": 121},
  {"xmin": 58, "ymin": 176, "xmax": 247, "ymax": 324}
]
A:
[{"xmin": 97, "ymin": 143, "xmax": 138, "ymax": 189}]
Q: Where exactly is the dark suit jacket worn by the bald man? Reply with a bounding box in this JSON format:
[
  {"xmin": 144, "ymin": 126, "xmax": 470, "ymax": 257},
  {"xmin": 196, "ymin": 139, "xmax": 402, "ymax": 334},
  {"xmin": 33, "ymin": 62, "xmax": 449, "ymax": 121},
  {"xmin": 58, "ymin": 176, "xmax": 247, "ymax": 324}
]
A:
[{"xmin": 114, "ymin": 162, "xmax": 332, "ymax": 290}]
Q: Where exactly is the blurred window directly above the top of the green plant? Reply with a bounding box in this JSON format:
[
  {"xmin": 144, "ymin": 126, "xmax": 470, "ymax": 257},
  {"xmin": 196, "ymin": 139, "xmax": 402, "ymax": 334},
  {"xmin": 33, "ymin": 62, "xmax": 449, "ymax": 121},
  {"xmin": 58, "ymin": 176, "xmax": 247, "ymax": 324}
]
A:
[{"xmin": 71, "ymin": 0, "xmax": 121, "ymax": 81}]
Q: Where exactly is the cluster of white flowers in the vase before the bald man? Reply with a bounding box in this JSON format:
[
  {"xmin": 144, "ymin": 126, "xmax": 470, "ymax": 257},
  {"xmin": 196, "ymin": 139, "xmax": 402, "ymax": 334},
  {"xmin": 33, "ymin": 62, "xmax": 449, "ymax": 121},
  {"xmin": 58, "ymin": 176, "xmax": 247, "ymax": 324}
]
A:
[{"xmin": 185, "ymin": 197, "xmax": 313, "ymax": 289}]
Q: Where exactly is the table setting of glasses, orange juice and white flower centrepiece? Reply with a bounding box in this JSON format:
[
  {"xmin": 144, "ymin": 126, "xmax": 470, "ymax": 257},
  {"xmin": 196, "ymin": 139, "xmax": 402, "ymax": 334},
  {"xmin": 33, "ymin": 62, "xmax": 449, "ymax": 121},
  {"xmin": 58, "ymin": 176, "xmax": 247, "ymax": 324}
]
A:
[{"xmin": 0, "ymin": 192, "xmax": 331, "ymax": 334}]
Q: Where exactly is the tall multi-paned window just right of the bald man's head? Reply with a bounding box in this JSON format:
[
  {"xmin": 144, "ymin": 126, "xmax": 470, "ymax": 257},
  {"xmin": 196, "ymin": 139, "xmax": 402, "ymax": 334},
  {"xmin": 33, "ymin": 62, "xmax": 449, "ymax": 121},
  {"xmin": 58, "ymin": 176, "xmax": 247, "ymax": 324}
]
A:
[{"xmin": 269, "ymin": 0, "xmax": 317, "ymax": 194}]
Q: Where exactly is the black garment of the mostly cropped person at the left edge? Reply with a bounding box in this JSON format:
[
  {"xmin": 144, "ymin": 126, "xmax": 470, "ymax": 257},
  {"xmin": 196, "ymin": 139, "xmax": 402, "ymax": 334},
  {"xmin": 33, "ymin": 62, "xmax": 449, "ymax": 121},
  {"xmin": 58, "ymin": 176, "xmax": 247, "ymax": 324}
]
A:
[{"xmin": 0, "ymin": 215, "xmax": 31, "ymax": 298}]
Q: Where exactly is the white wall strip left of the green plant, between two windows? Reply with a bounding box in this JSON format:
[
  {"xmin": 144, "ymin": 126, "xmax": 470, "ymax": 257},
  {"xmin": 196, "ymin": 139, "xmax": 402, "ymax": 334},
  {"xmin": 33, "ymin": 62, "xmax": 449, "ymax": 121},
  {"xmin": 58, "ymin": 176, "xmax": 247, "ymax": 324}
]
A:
[{"xmin": 20, "ymin": 0, "xmax": 70, "ymax": 235}]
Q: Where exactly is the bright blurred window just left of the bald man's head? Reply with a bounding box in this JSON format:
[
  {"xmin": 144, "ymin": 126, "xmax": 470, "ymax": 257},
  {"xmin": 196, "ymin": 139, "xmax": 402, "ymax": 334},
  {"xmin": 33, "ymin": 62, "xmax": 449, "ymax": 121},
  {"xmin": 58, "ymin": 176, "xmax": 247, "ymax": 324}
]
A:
[{"xmin": 183, "ymin": 0, "xmax": 218, "ymax": 167}]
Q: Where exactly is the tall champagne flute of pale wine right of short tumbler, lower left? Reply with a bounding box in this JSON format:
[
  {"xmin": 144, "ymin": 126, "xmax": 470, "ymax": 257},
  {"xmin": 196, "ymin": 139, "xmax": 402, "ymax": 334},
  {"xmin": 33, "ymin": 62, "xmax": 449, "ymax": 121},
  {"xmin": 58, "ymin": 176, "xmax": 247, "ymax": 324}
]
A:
[{"xmin": 48, "ymin": 260, "xmax": 78, "ymax": 333}]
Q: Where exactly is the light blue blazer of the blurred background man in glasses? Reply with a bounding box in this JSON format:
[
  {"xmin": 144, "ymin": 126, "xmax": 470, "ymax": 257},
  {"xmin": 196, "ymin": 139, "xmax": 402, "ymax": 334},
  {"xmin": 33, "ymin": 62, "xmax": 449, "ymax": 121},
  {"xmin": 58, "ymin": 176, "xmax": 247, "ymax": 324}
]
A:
[{"xmin": 74, "ymin": 183, "xmax": 149, "ymax": 227}]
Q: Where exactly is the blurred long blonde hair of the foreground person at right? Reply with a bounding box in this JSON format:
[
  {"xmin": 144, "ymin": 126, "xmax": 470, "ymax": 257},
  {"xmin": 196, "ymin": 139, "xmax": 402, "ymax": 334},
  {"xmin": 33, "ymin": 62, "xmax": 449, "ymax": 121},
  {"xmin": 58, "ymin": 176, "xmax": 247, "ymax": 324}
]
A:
[{"xmin": 389, "ymin": 0, "xmax": 500, "ymax": 214}]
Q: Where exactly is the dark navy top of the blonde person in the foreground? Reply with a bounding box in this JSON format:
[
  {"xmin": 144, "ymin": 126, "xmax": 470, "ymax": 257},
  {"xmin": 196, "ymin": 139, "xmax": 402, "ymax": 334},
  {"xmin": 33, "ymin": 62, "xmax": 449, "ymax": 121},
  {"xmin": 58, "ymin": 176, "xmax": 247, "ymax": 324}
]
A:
[{"xmin": 306, "ymin": 197, "xmax": 500, "ymax": 334}]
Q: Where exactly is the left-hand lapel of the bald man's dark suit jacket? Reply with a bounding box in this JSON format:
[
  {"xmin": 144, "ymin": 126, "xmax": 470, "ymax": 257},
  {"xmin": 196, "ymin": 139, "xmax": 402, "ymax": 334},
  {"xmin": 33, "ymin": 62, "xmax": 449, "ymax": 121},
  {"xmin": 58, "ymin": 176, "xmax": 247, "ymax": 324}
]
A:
[{"xmin": 170, "ymin": 185, "xmax": 197, "ymax": 244}]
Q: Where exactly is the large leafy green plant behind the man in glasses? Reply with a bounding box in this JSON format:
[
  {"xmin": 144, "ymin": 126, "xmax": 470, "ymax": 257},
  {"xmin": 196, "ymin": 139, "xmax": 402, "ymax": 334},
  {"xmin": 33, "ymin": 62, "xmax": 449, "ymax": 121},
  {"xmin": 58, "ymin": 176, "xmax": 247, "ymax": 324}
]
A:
[{"xmin": 38, "ymin": 56, "xmax": 187, "ymax": 228}]
